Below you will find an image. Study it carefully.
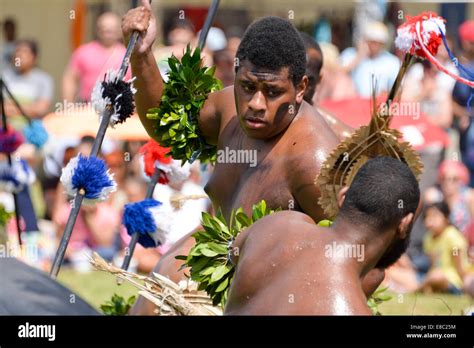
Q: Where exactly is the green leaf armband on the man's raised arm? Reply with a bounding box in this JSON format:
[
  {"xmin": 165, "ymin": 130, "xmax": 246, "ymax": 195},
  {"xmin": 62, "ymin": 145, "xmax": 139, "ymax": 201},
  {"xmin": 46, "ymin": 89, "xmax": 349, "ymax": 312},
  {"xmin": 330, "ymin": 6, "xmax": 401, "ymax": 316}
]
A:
[{"xmin": 147, "ymin": 45, "xmax": 222, "ymax": 163}]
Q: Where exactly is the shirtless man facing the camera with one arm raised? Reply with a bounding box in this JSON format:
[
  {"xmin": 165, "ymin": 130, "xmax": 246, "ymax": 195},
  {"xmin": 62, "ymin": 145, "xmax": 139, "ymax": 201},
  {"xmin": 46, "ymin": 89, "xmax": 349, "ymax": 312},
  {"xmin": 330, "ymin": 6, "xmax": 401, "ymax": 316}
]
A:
[{"xmin": 122, "ymin": 0, "xmax": 383, "ymax": 312}]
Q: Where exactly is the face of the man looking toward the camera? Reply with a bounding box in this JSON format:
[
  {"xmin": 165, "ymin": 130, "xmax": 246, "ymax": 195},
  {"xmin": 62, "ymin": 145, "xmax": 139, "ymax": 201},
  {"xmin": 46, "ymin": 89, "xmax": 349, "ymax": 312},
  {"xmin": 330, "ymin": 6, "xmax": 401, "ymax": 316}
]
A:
[{"xmin": 234, "ymin": 60, "xmax": 307, "ymax": 139}]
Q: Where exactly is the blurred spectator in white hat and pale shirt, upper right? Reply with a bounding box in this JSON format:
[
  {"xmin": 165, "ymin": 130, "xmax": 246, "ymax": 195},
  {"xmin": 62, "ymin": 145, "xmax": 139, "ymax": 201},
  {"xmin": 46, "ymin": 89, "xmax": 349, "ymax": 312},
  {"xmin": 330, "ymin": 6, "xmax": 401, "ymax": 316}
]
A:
[{"xmin": 340, "ymin": 22, "xmax": 400, "ymax": 98}]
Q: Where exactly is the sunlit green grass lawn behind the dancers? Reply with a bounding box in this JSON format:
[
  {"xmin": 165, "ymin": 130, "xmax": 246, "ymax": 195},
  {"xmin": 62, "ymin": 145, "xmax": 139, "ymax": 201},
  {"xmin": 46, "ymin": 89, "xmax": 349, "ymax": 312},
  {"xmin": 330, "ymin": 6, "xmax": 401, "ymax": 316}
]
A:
[{"xmin": 58, "ymin": 268, "xmax": 474, "ymax": 315}]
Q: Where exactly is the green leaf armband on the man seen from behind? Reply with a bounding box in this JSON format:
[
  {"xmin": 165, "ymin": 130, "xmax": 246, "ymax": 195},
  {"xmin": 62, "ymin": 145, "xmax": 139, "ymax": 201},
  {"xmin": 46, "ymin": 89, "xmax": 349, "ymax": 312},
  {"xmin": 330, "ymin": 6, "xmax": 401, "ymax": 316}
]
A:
[{"xmin": 180, "ymin": 200, "xmax": 280, "ymax": 307}]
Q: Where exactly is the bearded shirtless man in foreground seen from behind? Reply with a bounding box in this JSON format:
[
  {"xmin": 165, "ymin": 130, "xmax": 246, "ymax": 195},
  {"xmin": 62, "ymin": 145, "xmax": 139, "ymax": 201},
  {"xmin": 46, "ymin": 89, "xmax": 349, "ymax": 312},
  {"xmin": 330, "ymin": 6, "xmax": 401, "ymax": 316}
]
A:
[{"xmin": 224, "ymin": 157, "xmax": 420, "ymax": 315}]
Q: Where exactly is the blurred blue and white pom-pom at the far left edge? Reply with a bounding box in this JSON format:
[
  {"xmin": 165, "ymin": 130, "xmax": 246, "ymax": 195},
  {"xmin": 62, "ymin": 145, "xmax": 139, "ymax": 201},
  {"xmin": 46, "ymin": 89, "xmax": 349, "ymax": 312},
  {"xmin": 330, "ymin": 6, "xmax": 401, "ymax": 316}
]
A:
[{"xmin": 0, "ymin": 160, "xmax": 36, "ymax": 193}]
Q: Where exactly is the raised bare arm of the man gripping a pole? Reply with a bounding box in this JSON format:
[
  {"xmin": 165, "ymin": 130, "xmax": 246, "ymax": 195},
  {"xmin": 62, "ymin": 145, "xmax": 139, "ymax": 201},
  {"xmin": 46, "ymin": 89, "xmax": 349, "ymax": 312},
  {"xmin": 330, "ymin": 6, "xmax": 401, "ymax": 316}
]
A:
[{"xmin": 122, "ymin": 0, "xmax": 220, "ymax": 144}]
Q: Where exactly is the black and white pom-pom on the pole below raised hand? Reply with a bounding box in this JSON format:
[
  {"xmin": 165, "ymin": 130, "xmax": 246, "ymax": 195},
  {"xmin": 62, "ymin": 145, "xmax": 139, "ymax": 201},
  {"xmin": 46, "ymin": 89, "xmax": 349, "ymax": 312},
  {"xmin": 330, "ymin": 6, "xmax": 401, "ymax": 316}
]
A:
[{"xmin": 91, "ymin": 70, "xmax": 137, "ymax": 128}]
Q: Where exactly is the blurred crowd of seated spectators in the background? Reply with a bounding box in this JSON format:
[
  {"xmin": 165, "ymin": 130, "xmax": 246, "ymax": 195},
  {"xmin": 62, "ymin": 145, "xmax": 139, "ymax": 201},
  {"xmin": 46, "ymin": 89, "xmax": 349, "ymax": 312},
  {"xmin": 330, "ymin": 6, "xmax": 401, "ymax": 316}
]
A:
[{"xmin": 0, "ymin": 0, "xmax": 474, "ymax": 294}]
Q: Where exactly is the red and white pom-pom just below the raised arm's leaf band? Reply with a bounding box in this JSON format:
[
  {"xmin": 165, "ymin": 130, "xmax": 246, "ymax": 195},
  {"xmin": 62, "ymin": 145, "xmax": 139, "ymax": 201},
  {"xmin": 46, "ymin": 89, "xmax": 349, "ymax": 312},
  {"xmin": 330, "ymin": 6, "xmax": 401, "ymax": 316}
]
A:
[{"xmin": 140, "ymin": 140, "xmax": 191, "ymax": 184}]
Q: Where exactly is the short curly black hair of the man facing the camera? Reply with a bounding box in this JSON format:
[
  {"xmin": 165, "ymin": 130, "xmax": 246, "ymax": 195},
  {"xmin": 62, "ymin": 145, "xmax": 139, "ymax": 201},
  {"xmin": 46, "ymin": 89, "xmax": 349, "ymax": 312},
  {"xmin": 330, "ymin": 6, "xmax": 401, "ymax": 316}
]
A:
[{"xmin": 235, "ymin": 16, "xmax": 306, "ymax": 86}]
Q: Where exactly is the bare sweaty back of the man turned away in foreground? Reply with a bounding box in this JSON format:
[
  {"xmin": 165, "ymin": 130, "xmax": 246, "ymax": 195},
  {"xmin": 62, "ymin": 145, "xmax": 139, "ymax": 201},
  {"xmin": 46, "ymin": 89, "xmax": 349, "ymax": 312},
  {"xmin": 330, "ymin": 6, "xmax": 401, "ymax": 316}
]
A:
[{"xmin": 224, "ymin": 211, "xmax": 391, "ymax": 315}]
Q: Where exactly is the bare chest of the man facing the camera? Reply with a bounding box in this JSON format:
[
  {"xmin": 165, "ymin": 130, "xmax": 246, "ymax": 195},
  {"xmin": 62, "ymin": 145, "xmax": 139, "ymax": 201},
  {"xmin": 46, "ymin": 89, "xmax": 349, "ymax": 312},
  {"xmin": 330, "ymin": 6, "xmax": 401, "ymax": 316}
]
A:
[{"xmin": 205, "ymin": 121, "xmax": 295, "ymax": 216}]
